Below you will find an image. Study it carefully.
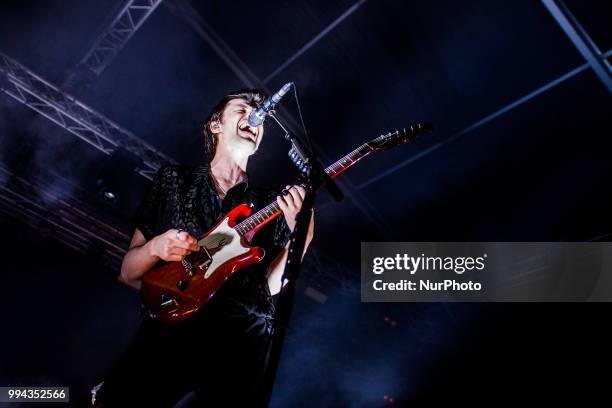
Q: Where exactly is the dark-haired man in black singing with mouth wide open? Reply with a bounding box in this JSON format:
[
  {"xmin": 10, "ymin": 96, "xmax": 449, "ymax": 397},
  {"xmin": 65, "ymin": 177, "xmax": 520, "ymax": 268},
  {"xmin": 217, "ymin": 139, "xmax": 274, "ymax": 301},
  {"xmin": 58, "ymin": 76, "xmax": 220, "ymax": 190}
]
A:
[{"xmin": 96, "ymin": 90, "xmax": 314, "ymax": 408}]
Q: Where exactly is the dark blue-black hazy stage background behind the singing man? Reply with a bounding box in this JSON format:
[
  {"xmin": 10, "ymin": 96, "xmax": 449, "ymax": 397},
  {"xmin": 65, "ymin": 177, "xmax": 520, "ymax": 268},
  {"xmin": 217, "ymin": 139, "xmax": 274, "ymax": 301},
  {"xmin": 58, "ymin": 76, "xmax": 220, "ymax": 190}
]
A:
[{"xmin": 0, "ymin": 0, "xmax": 612, "ymax": 407}]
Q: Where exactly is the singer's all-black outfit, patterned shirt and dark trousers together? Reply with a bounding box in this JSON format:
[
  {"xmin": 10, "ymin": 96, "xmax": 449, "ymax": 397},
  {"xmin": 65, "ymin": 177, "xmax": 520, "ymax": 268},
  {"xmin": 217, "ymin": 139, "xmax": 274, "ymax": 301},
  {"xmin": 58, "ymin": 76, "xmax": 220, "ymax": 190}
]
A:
[{"xmin": 97, "ymin": 166, "xmax": 289, "ymax": 407}]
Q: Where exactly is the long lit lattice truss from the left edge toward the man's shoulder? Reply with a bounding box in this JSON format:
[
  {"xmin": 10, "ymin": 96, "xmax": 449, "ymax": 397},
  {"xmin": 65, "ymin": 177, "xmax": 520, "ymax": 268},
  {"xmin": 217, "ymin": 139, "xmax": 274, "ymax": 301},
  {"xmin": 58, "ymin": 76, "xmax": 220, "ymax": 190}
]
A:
[{"xmin": 0, "ymin": 52, "xmax": 176, "ymax": 180}]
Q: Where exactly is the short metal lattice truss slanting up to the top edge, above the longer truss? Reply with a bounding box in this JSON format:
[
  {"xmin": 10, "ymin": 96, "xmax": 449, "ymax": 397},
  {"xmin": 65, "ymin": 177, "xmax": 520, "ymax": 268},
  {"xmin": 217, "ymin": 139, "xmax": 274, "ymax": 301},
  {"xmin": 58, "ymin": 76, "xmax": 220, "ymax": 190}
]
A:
[{"xmin": 65, "ymin": 0, "xmax": 162, "ymax": 89}]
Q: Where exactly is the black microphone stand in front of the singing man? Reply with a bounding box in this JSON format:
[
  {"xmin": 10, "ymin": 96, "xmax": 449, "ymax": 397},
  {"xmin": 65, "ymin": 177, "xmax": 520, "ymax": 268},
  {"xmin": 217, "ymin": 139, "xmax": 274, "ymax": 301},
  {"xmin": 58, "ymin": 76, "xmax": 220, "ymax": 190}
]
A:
[{"xmin": 258, "ymin": 111, "xmax": 343, "ymax": 407}]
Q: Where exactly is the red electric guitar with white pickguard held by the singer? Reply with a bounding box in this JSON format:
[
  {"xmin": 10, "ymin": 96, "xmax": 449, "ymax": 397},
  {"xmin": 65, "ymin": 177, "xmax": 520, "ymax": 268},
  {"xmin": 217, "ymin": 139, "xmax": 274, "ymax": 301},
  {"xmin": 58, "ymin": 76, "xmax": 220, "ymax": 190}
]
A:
[{"xmin": 141, "ymin": 124, "xmax": 432, "ymax": 323}]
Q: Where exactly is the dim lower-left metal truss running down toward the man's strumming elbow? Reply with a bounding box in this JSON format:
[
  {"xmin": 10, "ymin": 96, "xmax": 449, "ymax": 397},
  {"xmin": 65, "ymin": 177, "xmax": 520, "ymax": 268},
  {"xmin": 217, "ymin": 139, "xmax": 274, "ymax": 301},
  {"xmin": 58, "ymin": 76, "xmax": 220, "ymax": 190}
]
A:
[{"xmin": 0, "ymin": 166, "xmax": 130, "ymax": 271}]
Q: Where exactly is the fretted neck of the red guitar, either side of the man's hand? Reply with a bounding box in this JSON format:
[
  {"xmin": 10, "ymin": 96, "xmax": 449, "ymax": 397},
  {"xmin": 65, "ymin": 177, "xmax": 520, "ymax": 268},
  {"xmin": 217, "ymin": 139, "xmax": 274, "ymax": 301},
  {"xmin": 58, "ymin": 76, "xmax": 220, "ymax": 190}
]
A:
[{"xmin": 234, "ymin": 143, "xmax": 374, "ymax": 235}]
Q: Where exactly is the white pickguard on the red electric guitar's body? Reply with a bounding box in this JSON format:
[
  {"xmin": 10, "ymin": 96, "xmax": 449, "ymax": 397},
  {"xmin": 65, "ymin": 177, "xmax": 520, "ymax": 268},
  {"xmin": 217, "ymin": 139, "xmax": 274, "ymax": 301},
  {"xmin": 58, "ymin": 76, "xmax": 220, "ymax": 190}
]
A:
[{"xmin": 198, "ymin": 218, "xmax": 249, "ymax": 279}]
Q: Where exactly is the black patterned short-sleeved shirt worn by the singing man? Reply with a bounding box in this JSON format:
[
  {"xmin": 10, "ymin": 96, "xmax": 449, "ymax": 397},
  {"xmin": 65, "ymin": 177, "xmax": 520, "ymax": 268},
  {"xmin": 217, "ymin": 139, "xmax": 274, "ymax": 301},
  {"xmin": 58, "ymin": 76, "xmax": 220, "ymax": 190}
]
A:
[{"xmin": 133, "ymin": 165, "xmax": 290, "ymax": 318}]
